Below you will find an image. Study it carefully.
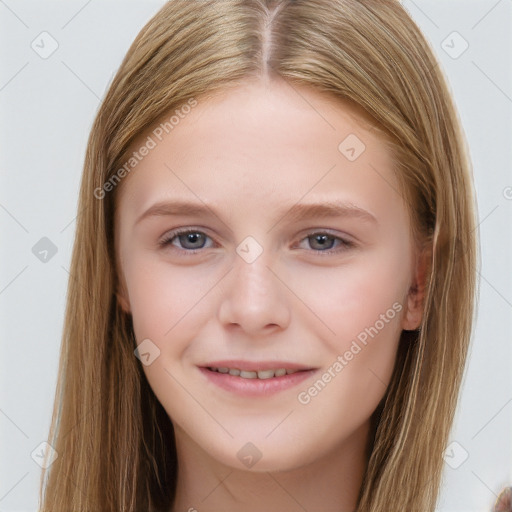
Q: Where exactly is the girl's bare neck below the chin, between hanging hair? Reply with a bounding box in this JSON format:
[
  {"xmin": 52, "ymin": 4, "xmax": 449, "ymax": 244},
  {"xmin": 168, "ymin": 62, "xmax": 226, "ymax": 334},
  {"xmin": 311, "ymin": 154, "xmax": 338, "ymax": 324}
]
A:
[{"xmin": 172, "ymin": 422, "xmax": 370, "ymax": 512}]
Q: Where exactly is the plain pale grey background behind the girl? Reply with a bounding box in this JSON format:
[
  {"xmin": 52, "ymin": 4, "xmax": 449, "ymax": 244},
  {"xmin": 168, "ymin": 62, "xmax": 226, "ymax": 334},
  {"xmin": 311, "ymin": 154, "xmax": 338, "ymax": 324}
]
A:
[{"xmin": 0, "ymin": 0, "xmax": 512, "ymax": 512}]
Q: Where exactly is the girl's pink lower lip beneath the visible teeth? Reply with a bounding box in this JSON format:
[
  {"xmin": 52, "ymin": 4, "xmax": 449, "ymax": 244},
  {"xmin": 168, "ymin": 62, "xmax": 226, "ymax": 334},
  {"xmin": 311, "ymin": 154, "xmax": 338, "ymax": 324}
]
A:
[{"xmin": 199, "ymin": 368, "xmax": 316, "ymax": 396}]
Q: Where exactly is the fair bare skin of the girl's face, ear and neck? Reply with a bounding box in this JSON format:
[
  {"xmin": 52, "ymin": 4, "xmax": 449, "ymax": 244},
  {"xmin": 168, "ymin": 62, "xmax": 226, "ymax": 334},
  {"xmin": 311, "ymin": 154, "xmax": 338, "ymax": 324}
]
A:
[{"xmin": 115, "ymin": 79, "xmax": 427, "ymax": 512}]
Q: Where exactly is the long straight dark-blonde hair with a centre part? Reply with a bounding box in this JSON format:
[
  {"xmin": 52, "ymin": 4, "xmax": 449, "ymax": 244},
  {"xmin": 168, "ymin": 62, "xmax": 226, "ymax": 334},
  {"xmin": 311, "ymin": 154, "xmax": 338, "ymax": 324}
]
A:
[{"xmin": 40, "ymin": 0, "xmax": 478, "ymax": 512}]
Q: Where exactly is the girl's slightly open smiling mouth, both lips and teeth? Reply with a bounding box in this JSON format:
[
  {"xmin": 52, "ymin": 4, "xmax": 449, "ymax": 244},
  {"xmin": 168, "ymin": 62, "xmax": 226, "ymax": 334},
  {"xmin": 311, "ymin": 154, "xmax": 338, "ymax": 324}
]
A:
[{"xmin": 199, "ymin": 361, "xmax": 317, "ymax": 396}]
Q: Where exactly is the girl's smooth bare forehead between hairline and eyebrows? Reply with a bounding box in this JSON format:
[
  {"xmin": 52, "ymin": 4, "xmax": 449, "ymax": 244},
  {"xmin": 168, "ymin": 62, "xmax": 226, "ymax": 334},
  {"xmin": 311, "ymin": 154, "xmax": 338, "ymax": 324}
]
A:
[{"xmin": 114, "ymin": 77, "xmax": 397, "ymax": 224}]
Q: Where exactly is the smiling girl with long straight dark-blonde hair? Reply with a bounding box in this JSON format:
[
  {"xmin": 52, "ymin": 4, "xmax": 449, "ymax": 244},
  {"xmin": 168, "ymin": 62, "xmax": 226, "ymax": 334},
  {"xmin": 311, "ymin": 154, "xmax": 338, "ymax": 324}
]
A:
[{"xmin": 37, "ymin": 0, "xmax": 477, "ymax": 512}]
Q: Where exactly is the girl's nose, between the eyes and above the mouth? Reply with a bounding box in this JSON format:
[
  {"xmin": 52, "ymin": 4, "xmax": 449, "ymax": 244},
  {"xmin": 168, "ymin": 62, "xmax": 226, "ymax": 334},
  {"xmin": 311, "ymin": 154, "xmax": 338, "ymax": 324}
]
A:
[{"xmin": 218, "ymin": 244, "xmax": 291, "ymax": 337}]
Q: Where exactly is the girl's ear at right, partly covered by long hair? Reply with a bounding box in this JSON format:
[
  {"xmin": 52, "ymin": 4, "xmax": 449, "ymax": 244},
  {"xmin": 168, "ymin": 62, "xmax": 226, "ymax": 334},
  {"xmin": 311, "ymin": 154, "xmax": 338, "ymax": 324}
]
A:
[{"xmin": 402, "ymin": 246, "xmax": 432, "ymax": 331}]
